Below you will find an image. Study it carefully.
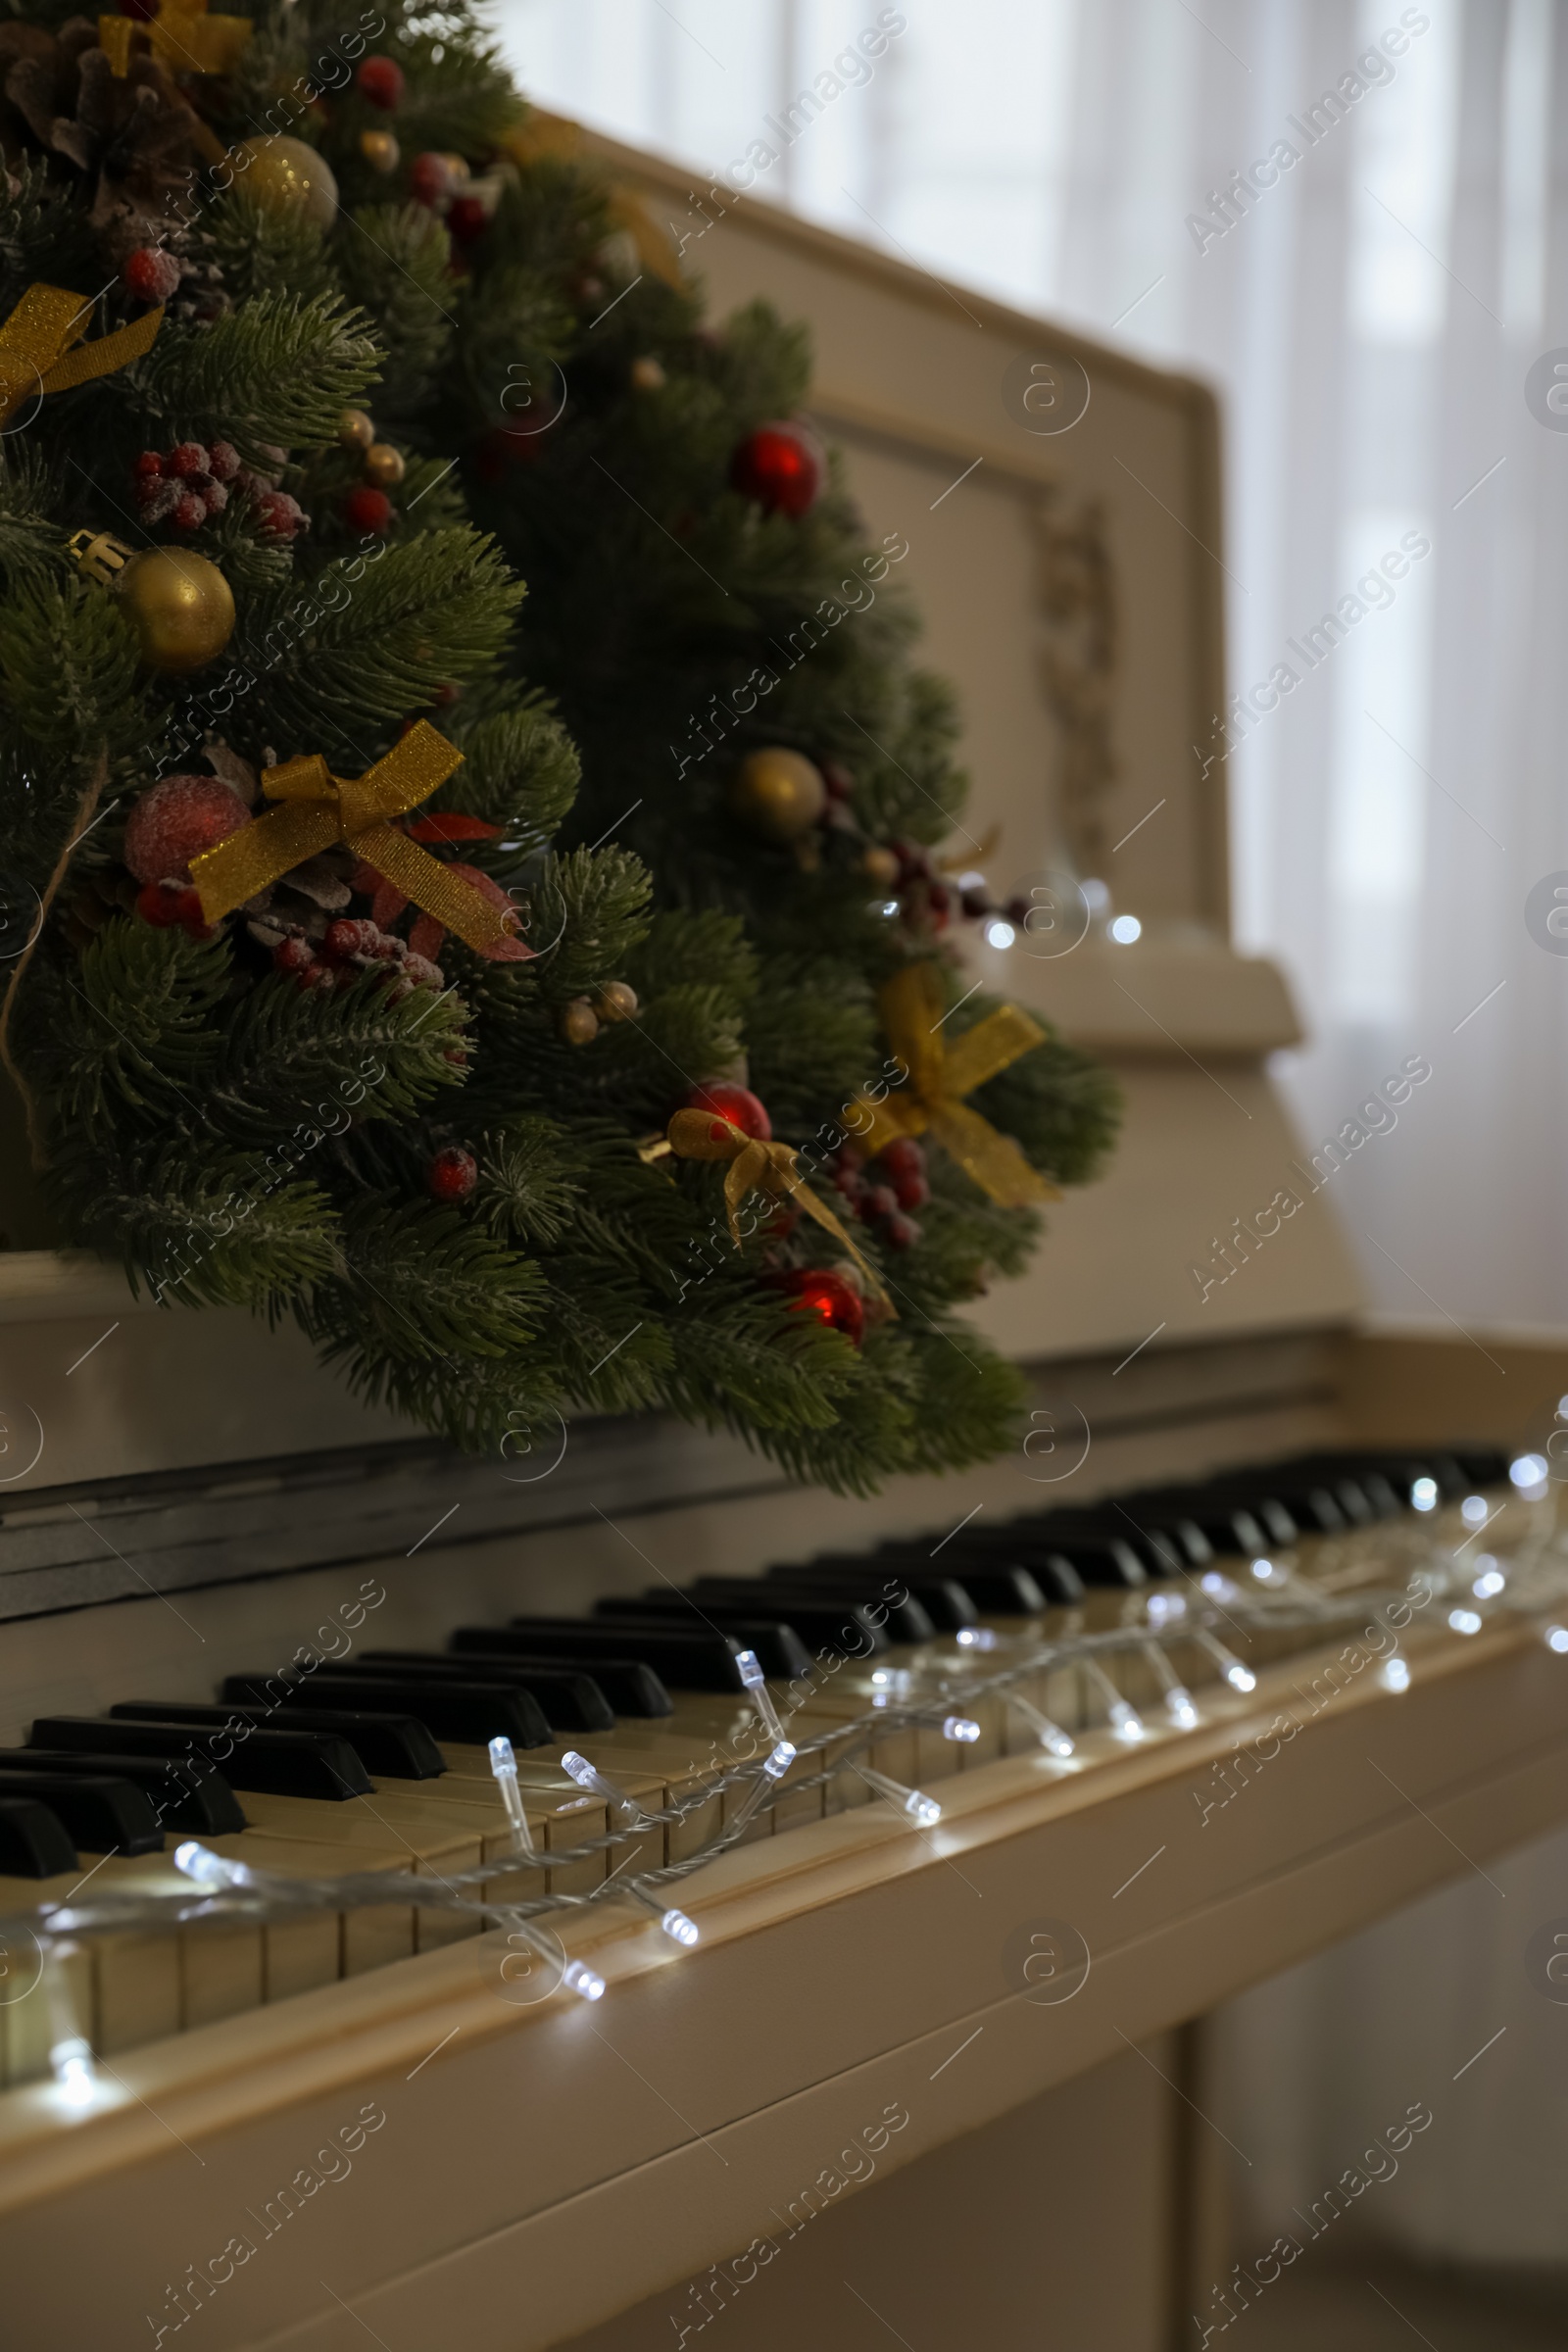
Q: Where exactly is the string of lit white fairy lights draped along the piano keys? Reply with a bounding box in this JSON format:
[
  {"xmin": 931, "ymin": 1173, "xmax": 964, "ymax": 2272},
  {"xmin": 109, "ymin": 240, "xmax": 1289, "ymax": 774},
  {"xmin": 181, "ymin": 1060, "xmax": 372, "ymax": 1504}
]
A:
[{"xmin": 12, "ymin": 1472, "xmax": 1568, "ymax": 2112}]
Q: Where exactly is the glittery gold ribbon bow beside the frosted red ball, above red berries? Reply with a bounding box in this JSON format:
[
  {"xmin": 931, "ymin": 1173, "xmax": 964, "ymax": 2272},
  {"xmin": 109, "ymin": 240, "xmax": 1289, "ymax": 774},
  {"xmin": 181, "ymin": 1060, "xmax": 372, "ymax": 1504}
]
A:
[{"xmin": 190, "ymin": 719, "xmax": 517, "ymax": 955}]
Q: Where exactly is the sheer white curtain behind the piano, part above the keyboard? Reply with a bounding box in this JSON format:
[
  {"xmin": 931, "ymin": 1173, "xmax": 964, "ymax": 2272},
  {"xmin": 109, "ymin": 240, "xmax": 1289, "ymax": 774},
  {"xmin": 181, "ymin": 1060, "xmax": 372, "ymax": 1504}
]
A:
[{"xmin": 499, "ymin": 0, "xmax": 1568, "ymax": 1329}]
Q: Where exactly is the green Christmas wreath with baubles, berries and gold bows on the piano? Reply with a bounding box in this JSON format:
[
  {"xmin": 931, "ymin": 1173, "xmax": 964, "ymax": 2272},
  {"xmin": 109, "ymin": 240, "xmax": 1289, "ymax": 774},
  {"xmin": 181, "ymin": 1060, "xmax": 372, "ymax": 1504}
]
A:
[{"xmin": 0, "ymin": 0, "xmax": 1116, "ymax": 1487}]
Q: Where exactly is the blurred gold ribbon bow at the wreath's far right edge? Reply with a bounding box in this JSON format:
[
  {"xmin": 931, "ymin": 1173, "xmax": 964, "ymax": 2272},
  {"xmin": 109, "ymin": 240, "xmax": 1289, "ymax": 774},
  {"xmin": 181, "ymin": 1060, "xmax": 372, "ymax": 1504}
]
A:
[{"xmin": 851, "ymin": 962, "xmax": 1060, "ymax": 1209}]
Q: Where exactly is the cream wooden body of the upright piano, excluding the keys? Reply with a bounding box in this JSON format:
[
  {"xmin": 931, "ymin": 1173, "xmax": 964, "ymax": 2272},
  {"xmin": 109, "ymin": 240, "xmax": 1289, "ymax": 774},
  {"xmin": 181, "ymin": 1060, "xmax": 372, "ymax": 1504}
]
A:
[{"xmin": 0, "ymin": 123, "xmax": 1568, "ymax": 2352}]
